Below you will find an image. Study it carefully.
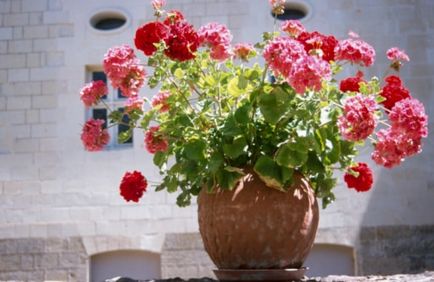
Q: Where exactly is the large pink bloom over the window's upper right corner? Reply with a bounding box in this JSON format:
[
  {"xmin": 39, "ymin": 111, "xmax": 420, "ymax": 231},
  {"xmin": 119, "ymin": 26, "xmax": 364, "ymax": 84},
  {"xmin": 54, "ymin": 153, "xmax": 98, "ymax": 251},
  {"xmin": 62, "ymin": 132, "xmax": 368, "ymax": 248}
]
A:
[{"xmin": 103, "ymin": 45, "xmax": 146, "ymax": 97}]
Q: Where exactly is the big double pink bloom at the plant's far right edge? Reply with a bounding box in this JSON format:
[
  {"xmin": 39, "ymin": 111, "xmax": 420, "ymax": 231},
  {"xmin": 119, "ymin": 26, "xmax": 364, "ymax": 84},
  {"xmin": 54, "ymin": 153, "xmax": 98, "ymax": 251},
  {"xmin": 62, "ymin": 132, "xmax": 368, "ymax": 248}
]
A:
[{"xmin": 372, "ymin": 98, "xmax": 428, "ymax": 168}]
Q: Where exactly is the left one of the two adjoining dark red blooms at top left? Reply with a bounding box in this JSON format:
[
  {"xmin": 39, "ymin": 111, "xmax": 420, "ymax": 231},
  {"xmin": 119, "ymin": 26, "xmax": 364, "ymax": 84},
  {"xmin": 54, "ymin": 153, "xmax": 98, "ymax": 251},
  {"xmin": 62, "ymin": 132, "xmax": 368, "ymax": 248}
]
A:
[{"xmin": 134, "ymin": 22, "xmax": 169, "ymax": 56}]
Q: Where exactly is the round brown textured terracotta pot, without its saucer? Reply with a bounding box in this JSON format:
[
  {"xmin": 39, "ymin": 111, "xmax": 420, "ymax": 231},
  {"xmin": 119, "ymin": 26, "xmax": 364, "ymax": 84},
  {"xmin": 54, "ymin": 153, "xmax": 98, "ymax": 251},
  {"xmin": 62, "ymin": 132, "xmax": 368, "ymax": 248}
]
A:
[{"xmin": 198, "ymin": 169, "xmax": 319, "ymax": 269}]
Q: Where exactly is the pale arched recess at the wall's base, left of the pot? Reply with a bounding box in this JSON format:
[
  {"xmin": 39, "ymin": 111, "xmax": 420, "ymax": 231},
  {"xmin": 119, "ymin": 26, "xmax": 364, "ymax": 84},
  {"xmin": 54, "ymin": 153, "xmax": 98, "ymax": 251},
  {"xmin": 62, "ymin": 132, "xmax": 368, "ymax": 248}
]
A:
[{"xmin": 89, "ymin": 250, "xmax": 161, "ymax": 282}]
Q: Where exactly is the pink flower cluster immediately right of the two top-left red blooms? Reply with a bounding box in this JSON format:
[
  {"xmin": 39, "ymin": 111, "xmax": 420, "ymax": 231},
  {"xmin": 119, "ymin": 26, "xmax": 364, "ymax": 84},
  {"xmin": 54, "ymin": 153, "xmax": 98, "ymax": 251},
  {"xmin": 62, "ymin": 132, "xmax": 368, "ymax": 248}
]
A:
[{"xmin": 198, "ymin": 22, "xmax": 232, "ymax": 61}]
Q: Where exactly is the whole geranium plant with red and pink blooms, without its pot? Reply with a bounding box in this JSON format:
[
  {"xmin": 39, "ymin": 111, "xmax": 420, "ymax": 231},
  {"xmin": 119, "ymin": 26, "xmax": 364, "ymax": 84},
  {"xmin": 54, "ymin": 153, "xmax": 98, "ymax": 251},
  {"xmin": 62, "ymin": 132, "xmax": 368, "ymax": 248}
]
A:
[{"xmin": 81, "ymin": 0, "xmax": 427, "ymax": 207}]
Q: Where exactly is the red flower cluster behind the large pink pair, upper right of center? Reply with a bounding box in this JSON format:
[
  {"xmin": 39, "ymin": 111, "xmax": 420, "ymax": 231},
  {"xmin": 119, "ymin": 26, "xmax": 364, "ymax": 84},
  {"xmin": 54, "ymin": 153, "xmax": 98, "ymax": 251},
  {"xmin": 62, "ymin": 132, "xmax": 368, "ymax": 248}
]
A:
[{"xmin": 297, "ymin": 31, "xmax": 338, "ymax": 62}]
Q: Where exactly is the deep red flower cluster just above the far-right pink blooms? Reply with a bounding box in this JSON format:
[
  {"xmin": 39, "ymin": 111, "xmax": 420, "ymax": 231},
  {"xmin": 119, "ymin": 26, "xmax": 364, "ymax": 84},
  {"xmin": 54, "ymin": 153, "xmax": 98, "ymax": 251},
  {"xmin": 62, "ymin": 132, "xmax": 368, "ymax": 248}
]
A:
[{"xmin": 380, "ymin": 75, "xmax": 411, "ymax": 110}]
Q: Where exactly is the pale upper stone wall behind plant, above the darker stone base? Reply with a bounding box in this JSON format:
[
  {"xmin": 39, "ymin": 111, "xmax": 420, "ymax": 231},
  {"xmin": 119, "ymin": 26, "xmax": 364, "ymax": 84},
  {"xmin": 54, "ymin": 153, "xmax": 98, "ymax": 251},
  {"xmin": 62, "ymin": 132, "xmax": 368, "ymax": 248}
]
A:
[{"xmin": 0, "ymin": 0, "xmax": 434, "ymax": 280}]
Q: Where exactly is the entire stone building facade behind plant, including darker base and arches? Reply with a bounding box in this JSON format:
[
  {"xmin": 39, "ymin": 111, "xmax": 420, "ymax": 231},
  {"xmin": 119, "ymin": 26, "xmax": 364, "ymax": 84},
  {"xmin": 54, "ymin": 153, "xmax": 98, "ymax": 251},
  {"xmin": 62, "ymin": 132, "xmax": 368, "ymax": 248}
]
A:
[{"xmin": 0, "ymin": 0, "xmax": 434, "ymax": 281}]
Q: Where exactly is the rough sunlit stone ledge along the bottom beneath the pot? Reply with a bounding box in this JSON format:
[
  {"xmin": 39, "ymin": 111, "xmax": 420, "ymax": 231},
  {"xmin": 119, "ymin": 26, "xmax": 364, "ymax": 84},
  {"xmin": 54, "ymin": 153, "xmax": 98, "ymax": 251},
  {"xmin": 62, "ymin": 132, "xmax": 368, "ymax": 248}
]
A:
[{"xmin": 106, "ymin": 271, "xmax": 434, "ymax": 282}]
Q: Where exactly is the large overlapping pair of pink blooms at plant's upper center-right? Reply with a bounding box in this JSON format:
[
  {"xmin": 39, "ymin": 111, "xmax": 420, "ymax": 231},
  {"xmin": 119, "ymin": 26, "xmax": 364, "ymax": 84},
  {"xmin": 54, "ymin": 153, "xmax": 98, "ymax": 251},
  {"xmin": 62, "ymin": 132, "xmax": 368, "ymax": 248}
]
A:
[{"xmin": 264, "ymin": 37, "xmax": 331, "ymax": 94}]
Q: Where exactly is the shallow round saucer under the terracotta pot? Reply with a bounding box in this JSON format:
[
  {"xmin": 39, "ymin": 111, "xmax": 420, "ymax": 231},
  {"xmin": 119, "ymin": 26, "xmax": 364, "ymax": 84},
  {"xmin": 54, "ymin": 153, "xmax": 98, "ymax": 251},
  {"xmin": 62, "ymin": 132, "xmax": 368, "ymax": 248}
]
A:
[{"xmin": 214, "ymin": 267, "xmax": 308, "ymax": 282}]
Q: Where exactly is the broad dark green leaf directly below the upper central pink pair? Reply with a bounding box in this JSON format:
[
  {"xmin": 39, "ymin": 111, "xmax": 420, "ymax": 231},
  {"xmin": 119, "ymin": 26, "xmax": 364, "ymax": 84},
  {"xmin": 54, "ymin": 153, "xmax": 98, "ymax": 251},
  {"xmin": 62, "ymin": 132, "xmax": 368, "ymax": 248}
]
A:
[{"xmin": 258, "ymin": 86, "xmax": 292, "ymax": 124}]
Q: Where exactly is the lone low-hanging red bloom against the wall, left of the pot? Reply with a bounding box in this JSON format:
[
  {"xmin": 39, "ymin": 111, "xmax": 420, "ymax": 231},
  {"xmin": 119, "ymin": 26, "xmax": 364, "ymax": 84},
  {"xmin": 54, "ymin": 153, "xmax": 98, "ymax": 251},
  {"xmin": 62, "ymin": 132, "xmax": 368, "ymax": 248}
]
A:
[{"xmin": 119, "ymin": 171, "xmax": 148, "ymax": 203}]
